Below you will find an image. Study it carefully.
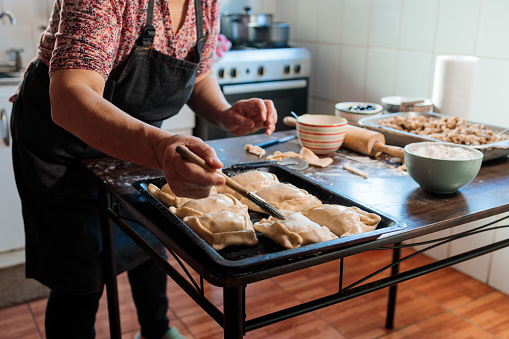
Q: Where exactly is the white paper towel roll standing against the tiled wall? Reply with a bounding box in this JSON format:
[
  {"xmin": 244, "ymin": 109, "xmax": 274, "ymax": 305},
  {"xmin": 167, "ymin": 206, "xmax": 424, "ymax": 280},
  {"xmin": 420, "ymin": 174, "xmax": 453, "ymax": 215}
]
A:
[{"xmin": 432, "ymin": 55, "xmax": 479, "ymax": 118}]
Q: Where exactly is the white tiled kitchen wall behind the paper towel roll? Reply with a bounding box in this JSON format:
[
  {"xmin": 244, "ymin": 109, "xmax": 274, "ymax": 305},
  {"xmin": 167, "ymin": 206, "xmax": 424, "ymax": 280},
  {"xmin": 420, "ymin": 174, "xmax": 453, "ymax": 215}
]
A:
[{"xmin": 248, "ymin": 0, "xmax": 509, "ymax": 127}]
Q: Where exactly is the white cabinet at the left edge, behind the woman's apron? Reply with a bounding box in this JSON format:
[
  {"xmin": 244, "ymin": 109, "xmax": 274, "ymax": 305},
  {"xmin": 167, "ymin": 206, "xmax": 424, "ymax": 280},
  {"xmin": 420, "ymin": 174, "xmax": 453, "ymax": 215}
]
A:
[{"xmin": 0, "ymin": 85, "xmax": 25, "ymax": 268}]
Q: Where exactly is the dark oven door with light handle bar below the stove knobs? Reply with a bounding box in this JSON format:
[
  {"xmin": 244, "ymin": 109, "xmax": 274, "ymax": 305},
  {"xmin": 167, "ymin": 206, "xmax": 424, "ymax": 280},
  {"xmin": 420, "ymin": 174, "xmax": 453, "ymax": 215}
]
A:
[{"xmin": 195, "ymin": 79, "xmax": 309, "ymax": 140}]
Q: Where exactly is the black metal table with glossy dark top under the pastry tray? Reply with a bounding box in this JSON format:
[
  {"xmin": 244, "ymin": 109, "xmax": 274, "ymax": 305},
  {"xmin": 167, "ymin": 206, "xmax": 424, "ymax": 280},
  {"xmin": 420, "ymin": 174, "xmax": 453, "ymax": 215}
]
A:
[{"xmin": 84, "ymin": 131, "xmax": 509, "ymax": 339}]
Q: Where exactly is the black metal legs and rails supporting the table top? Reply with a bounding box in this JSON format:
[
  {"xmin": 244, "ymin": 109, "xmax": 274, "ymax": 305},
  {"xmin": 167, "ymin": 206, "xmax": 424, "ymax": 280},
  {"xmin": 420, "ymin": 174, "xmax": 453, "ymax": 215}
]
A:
[{"xmin": 96, "ymin": 190, "xmax": 509, "ymax": 339}]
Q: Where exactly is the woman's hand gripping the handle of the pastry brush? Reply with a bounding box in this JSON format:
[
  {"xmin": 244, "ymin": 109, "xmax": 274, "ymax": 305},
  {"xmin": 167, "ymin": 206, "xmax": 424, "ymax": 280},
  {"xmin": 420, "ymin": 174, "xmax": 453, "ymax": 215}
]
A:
[{"xmin": 156, "ymin": 135, "xmax": 225, "ymax": 199}]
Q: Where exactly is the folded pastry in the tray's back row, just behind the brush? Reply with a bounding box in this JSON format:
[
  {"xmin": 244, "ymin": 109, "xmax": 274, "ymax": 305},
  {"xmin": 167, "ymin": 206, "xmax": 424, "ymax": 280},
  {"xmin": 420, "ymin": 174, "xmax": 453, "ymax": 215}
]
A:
[{"xmin": 241, "ymin": 183, "xmax": 322, "ymax": 212}]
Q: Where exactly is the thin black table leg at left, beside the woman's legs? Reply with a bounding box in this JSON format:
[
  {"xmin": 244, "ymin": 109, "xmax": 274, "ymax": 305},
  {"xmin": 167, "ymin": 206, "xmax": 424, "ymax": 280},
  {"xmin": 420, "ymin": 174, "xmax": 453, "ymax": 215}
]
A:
[{"xmin": 99, "ymin": 189, "xmax": 122, "ymax": 339}]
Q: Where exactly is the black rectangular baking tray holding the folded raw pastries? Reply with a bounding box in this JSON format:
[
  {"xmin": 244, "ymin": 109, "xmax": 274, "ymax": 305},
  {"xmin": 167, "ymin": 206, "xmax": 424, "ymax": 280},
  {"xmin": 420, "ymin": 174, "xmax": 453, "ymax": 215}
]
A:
[{"xmin": 133, "ymin": 164, "xmax": 406, "ymax": 268}]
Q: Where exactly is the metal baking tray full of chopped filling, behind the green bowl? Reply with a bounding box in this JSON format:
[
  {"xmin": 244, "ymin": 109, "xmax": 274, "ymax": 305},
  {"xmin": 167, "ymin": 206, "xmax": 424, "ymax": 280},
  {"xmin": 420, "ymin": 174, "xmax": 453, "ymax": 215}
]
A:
[{"xmin": 359, "ymin": 112, "xmax": 509, "ymax": 161}]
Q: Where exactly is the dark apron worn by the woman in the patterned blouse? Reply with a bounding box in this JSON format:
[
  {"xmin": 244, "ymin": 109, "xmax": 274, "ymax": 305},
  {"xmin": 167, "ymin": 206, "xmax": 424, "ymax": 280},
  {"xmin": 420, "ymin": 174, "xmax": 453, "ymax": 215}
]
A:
[{"xmin": 11, "ymin": 0, "xmax": 207, "ymax": 293}]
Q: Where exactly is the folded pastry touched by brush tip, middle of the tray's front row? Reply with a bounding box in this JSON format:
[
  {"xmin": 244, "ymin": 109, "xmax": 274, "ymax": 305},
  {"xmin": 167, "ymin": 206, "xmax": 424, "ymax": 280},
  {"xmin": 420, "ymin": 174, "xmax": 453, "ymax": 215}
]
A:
[{"xmin": 253, "ymin": 211, "xmax": 338, "ymax": 249}]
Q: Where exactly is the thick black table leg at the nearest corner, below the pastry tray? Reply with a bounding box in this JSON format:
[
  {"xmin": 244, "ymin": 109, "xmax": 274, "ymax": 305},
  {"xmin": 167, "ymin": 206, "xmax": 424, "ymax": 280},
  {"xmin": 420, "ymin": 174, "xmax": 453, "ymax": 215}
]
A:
[{"xmin": 223, "ymin": 285, "xmax": 246, "ymax": 339}]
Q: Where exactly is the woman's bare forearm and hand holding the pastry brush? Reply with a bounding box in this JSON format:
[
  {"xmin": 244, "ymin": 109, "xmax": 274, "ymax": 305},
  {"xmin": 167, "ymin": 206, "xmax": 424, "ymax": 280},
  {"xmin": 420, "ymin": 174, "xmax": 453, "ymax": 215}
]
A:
[{"xmin": 50, "ymin": 69, "xmax": 224, "ymax": 197}]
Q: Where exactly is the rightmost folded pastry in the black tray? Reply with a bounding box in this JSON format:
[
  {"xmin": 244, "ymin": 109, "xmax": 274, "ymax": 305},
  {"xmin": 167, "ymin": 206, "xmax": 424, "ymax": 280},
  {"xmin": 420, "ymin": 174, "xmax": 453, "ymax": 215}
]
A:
[{"xmin": 302, "ymin": 204, "xmax": 381, "ymax": 237}]
